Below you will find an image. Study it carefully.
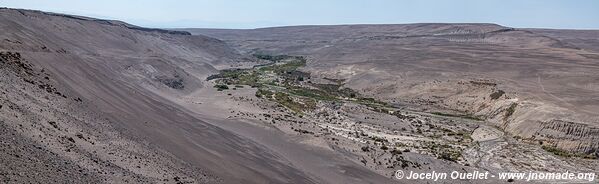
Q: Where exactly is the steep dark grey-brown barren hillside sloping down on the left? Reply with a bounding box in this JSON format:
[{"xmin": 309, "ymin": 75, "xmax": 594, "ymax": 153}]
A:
[{"xmin": 0, "ymin": 9, "xmax": 332, "ymax": 183}]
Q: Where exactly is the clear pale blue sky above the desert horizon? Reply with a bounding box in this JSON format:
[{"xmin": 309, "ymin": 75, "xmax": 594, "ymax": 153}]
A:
[{"xmin": 0, "ymin": 0, "xmax": 599, "ymax": 29}]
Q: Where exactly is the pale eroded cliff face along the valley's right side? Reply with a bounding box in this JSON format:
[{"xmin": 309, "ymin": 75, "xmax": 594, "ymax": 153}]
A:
[{"xmin": 348, "ymin": 72, "xmax": 599, "ymax": 156}]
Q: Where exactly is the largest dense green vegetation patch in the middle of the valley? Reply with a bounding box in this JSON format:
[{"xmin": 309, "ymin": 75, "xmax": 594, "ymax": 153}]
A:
[{"xmin": 207, "ymin": 54, "xmax": 391, "ymax": 113}]
